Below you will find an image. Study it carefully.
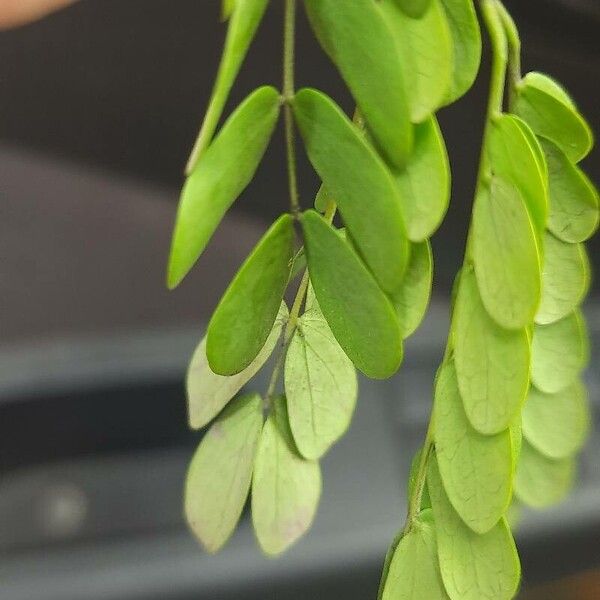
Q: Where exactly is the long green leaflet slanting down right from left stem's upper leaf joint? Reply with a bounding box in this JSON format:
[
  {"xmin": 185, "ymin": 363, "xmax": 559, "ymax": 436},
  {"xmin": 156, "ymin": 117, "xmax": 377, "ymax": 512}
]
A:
[{"xmin": 293, "ymin": 88, "xmax": 410, "ymax": 292}]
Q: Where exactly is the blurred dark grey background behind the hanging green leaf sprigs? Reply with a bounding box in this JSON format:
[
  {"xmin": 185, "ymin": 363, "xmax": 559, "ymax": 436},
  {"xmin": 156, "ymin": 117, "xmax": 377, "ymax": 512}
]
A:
[{"xmin": 0, "ymin": 0, "xmax": 600, "ymax": 600}]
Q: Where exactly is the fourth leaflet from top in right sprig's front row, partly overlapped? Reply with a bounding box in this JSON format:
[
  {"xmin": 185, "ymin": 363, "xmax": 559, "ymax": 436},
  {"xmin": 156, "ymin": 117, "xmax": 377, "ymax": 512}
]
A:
[{"xmin": 430, "ymin": 363, "xmax": 513, "ymax": 534}]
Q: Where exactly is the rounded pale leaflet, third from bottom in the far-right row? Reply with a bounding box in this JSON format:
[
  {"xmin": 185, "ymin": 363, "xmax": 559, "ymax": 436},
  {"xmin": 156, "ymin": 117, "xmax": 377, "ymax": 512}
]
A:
[{"xmin": 531, "ymin": 311, "xmax": 588, "ymax": 394}]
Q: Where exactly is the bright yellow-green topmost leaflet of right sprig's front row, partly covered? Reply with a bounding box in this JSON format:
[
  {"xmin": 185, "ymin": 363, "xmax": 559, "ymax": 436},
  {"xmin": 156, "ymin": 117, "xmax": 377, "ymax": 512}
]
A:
[{"xmin": 487, "ymin": 115, "xmax": 548, "ymax": 235}]
